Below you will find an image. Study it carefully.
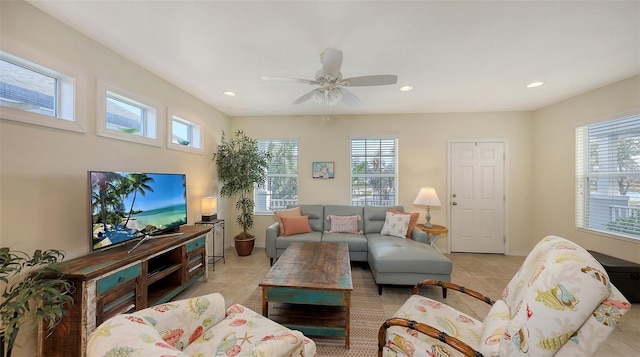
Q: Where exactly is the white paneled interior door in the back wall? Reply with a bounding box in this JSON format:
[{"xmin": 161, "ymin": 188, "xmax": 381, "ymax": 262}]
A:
[{"xmin": 449, "ymin": 141, "xmax": 505, "ymax": 253}]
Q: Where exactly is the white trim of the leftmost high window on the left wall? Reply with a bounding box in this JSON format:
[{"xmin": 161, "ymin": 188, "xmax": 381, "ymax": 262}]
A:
[{"xmin": 0, "ymin": 39, "xmax": 87, "ymax": 133}]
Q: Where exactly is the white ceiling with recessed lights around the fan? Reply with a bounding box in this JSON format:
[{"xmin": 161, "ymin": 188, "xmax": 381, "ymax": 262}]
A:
[{"xmin": 29, "ymin": 0, "xmax": 640, "ymax": 116}]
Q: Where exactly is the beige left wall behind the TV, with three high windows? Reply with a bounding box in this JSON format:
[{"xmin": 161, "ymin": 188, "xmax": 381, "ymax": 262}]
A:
[{"xmin": 0, "ymin": 1, "xmax": 229, "ymax": 258}]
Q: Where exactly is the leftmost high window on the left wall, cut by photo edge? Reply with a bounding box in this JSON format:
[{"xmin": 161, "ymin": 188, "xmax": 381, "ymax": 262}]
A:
[{"xmin": 0, "ymin": 44, "xmax": 86, "ymax": 132}]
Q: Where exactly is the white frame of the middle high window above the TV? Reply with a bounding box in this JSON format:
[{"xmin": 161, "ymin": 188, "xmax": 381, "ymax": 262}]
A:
[{"xmin": 96, "ymin": 80, "xmax": 166, "ymax": 147}]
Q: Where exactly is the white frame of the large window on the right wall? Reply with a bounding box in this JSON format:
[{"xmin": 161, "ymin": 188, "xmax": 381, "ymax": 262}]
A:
[{"xmin": 574, "ymin": 109, "xmax": 640, "ymax": 243}]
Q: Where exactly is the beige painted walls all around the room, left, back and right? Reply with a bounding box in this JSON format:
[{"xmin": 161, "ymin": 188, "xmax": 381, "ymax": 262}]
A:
[{"xmin": 0, "ymin": 1, "xmax": 640, "ymax": 356}]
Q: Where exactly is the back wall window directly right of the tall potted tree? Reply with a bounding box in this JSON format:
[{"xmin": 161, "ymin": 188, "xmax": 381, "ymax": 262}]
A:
[{"xmin": 254, "ymin": 139, "xmax": 298, "ymax": 213}]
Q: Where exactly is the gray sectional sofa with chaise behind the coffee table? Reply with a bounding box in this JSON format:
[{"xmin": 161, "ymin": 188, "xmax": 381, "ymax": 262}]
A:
[{"xmin": 266, "ymin": 205, "xmax": 452, "ymax": 297}]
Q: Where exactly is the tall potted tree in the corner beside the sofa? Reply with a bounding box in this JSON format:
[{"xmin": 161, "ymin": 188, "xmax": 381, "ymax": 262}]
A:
[{"xmin": 213, "ymin": 130, "xmax": 271, "ymax": 256}]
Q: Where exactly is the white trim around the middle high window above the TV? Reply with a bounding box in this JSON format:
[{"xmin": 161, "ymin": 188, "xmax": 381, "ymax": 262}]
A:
[{"xmin": 96, "ymin": 79, "xmax": 166, "ymax": 147}]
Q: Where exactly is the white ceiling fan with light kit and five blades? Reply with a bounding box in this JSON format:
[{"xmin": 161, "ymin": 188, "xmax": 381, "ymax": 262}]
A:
[{"xmin": 262, "ymin": 48, "xmax": 398, "ymax": 107}]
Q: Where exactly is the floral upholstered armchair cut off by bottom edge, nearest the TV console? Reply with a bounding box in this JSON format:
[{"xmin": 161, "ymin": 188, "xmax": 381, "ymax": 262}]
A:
[{"xmin": 87, "ymin": 293, "xmax": 316, "ymax": 357}]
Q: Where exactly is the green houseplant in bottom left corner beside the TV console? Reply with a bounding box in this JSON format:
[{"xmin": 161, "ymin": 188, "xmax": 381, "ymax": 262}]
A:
[{"xmin": 0, "ymin": 247, "xmax": 73, "ymax": 357}]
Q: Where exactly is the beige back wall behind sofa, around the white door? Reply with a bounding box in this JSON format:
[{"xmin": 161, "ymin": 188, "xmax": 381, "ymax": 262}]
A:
[{"xmin": 227, "ymin": 112, "xmax": 533, "ymax": 252}]
